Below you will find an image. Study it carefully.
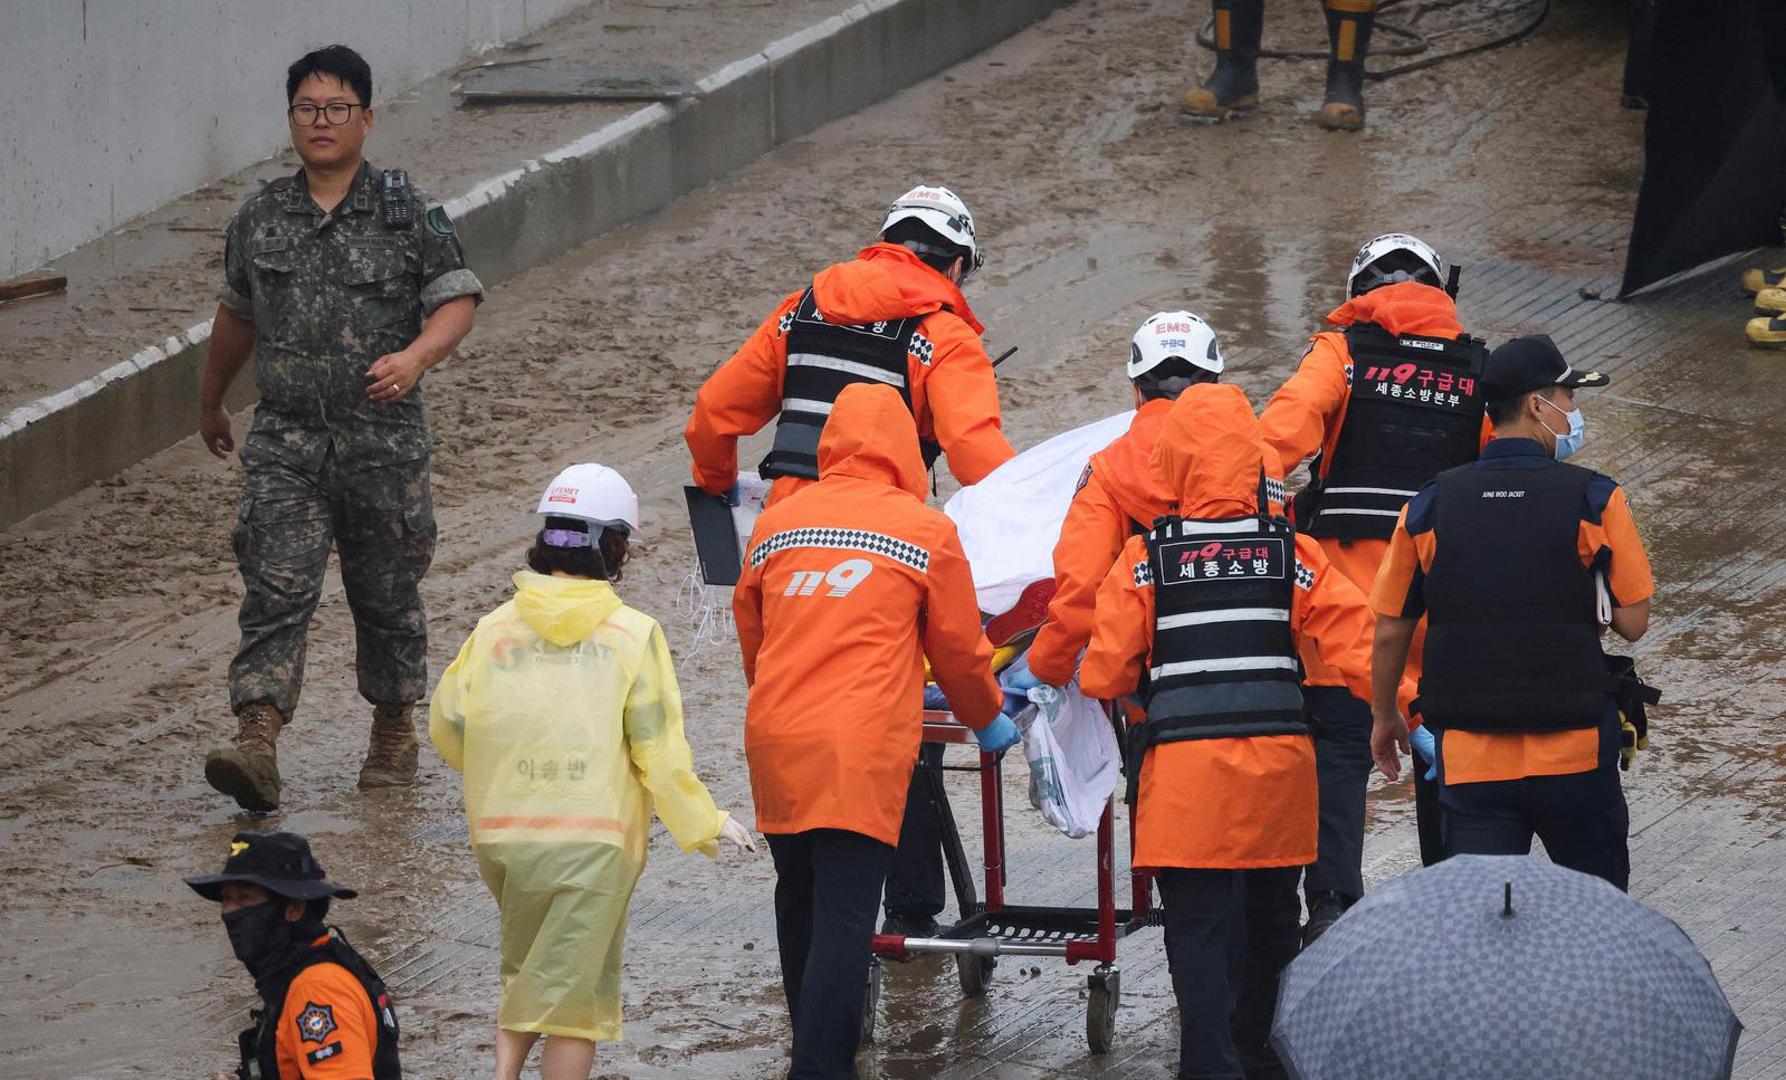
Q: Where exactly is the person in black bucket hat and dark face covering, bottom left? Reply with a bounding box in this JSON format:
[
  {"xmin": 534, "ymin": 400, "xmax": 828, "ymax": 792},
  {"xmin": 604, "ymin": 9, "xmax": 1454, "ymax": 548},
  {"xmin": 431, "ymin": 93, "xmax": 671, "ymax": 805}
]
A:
[{"xmin": 184, "ymin": 832, "xmax": 402, "ymax": 1080}]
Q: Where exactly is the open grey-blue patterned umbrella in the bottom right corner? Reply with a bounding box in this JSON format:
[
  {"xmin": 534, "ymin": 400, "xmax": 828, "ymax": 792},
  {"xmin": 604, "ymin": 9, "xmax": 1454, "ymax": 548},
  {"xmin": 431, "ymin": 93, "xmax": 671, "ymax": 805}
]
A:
[{"xmin": 1272, "ymin": 855, "xmax": 1743, "ymax": 1080}]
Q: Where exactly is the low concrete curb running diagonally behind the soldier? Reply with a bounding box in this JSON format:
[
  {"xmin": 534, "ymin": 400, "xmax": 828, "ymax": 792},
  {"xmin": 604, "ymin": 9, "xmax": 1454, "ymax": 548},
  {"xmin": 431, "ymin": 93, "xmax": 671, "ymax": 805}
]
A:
[{"xmin": 0, "ymin": 0, "xmax": 1068, "ymax": 527}]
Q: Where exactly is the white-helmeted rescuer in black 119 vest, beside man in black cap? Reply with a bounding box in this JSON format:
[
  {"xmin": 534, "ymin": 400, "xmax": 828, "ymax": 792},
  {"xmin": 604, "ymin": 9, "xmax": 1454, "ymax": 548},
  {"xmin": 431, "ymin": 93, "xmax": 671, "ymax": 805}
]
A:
[{"xmin": 1259, "ymin": 234, "xmax": 1490, "ymax": 944}]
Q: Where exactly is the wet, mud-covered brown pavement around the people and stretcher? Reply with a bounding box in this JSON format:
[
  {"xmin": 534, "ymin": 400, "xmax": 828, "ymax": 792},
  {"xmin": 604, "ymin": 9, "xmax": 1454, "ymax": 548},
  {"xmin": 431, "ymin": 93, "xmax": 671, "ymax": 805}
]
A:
[{"xmin": 0, "ymin": 0, "xmax": 1786, "ymax": 1076}]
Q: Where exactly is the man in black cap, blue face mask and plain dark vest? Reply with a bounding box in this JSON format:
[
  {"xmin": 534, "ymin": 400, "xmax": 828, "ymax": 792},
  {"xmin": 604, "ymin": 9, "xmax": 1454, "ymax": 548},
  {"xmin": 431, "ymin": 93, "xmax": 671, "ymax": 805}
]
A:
[{"xmin": 1372, "ymin": 334, "xmax": 1656, "ymax": 889}]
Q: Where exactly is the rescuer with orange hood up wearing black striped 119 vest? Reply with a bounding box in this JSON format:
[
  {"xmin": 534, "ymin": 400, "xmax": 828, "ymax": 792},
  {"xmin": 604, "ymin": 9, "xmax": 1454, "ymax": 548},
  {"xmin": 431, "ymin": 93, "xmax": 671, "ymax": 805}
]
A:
[{"xmin": 1081, "ymin": 386, "xmax": 1400, "ymax": 1076}]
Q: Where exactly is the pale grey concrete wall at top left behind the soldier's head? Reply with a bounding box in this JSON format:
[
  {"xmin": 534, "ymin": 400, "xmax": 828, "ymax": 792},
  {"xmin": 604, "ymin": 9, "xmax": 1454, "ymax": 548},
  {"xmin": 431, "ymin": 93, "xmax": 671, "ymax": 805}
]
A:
[{"xmin": 0, "ymin": 0, "xmax": 589, "ymax": 278}]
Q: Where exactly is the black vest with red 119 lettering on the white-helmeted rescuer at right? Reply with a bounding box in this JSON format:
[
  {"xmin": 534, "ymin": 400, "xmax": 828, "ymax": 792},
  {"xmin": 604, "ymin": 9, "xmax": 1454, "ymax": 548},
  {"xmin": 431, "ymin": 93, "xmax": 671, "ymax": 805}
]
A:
[{"xmin": 1298, "ymin": 323, "xmax": 1488, "ymax": 539}]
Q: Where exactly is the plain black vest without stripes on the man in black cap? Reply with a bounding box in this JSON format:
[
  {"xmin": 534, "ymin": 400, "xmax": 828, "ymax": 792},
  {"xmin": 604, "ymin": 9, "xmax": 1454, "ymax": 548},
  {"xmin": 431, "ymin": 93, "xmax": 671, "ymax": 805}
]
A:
[{"xmin": 1418, "ymin": 455, "xmax": 1613, "ymax": 732}]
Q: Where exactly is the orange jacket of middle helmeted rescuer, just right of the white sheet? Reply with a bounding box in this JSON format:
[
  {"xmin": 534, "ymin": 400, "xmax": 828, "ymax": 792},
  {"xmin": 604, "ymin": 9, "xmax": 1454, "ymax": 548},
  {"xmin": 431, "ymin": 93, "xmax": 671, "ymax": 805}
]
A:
[{"xmin": 1029, "ymin": 398, "xmax": 1177, "ymax": 685}]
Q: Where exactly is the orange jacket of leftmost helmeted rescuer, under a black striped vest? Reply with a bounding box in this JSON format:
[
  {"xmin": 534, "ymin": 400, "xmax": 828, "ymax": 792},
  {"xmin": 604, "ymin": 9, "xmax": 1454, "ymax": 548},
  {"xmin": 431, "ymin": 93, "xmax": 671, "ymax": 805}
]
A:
[{"xmin": 682, "ymin": 243, "xmax": 1016, "ymax": 505}]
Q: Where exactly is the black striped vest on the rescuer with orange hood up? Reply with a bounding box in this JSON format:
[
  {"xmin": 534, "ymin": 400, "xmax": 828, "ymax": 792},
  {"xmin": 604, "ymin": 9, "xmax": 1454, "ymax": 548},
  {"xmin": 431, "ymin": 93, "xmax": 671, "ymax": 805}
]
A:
[{"xmin": 1129, "ymin": 491, "xmax": 1309, "ymax": 802}]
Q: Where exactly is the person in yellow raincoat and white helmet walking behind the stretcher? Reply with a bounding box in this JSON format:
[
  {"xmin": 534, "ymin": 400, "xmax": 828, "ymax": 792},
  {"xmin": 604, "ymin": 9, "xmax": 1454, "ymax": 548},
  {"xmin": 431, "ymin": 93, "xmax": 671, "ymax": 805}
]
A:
[{"xmin": 429, "ymin": 464, "xmax": 755, "ymax": 1080}]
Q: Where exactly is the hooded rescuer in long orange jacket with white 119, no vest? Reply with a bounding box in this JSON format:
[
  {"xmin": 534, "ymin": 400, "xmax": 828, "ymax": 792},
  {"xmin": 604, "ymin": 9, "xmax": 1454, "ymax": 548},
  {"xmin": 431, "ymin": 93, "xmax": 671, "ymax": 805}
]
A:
[{"xmin": 732, "ymin": 386, "xmax": 1018, "ymax": 1078}]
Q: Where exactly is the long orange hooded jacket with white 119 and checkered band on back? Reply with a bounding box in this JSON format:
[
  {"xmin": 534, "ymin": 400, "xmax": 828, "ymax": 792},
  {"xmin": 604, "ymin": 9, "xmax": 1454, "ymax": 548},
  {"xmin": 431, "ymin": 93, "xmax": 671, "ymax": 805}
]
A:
[{"xmin": 732, "ymin": 384, "xmax": 1004, "ymax": 844}]
